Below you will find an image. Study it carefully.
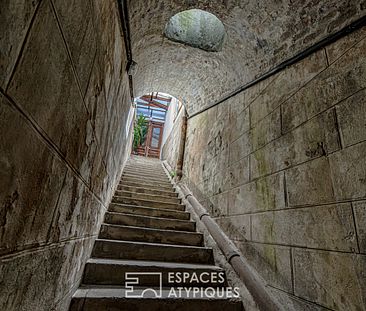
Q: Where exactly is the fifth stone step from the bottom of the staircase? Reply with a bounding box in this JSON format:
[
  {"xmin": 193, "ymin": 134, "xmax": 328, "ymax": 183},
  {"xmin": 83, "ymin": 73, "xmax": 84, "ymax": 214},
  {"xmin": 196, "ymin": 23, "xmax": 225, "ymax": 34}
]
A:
[{"xmin": 104, "ymin": 212, "xmax": 196, "ymax": 232}]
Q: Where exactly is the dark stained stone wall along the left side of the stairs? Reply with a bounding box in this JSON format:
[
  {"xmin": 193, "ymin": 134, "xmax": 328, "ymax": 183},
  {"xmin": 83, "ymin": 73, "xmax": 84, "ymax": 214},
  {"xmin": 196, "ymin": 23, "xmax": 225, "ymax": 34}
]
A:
[{"xmin": 0, "ymin": 0, "xmax": 131, "ymax": 311}]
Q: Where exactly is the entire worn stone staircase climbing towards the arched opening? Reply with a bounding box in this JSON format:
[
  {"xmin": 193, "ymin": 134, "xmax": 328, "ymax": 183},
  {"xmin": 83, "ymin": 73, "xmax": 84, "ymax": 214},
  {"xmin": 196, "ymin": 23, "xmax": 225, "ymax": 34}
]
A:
[{"xmin": 70, "ymin": 157, "xmax": 242, "ymax": 311}]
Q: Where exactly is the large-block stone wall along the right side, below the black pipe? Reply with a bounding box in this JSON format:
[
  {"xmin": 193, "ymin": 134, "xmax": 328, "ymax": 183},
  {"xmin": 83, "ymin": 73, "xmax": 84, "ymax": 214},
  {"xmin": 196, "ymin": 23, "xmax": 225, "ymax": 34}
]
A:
[{"xmin": 184, "ymin": 28, "xmax": 366, "ymax": 310}]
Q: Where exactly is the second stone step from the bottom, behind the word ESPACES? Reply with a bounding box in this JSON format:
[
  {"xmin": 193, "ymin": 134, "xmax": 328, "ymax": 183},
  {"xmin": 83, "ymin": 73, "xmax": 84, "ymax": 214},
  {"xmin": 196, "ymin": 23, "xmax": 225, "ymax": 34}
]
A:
[{"xmin": 83, "ymin": 258, "xmax": 227, "ymax": 287}]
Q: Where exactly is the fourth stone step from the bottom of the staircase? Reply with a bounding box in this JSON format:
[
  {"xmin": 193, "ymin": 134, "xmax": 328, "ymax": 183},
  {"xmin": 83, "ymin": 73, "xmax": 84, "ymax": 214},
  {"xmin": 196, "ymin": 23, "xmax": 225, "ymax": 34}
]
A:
[{"xmin": 99, "ymin": 224, "xmax": 203, "ymax": 246}]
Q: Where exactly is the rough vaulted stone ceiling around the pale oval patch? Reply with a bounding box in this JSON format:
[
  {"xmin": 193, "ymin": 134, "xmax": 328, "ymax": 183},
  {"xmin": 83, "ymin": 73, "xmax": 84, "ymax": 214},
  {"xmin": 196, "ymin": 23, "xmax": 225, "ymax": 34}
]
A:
[{"xmin": 128, "ymin": 0, "xmax": 366, "ymax": 113}]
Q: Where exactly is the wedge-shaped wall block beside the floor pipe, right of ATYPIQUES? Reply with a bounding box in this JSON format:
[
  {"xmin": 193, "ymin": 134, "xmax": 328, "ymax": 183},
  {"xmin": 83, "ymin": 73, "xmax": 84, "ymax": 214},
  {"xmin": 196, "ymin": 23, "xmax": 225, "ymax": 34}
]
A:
[{"xmin": 236, "ymin": 242, "xmax": 292, "ymax": 292}]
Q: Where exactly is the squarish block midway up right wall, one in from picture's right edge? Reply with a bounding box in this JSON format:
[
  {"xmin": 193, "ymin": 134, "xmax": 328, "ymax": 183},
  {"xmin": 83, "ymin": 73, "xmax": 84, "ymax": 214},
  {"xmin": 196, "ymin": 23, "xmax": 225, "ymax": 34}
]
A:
[{"xmin": 285, "ymin": 157, "xmax": 335, "ymax": 206}]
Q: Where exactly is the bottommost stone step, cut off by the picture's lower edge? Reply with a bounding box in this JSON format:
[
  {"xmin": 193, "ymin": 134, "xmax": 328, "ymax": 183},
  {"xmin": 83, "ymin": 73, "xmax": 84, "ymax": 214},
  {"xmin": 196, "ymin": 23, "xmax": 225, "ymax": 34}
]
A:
[{"xmin": 70, "ymin": 285, "xmax": 243, "ymax": 311}]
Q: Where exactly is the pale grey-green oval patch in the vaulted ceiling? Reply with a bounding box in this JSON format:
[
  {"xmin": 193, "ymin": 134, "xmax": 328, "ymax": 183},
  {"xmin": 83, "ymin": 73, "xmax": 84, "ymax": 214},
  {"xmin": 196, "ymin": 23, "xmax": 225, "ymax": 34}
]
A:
[{"xmin": 165, "ymin": 9, "xmax": 225, "ymax": 52}]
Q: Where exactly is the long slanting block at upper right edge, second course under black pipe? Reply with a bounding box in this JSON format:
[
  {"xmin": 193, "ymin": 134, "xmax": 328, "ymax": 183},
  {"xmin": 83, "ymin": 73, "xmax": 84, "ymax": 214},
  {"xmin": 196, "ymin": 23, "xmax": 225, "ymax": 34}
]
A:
[{"xmin": 282, "ymin": 39, "xmax": 366, "ymax": 132}]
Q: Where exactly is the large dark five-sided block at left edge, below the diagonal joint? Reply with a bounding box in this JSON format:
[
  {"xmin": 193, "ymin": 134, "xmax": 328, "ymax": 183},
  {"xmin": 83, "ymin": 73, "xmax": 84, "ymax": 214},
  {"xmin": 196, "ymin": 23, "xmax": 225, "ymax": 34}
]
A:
[{"xmin": 0, "ymin": 95, "xmax": 66, "ymax": 254}]
